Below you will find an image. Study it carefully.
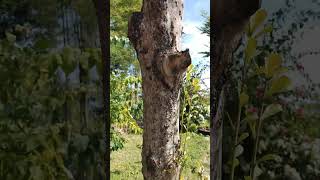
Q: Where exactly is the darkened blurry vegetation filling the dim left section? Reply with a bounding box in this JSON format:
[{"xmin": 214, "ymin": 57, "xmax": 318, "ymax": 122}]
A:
[{"xmin": 0, "ymin": 0, "xmax": 106, "ymax": 180}]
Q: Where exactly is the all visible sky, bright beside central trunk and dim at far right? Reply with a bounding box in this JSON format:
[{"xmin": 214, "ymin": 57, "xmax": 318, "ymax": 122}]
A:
[{"xmin": 182, "ymin": 0, "xmax": 320, "ymax": 87}]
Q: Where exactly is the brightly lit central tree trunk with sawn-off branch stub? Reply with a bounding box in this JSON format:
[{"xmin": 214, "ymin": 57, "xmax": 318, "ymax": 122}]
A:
[{"xmin": 128, "ymin": 0, "xmax": 191, "ymax": 180}]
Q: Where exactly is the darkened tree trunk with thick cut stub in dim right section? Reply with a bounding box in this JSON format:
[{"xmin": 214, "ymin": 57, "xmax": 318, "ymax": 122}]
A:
[{"xmin": 210, "ymin": 0, "xmax": 261, "ymax": 180}]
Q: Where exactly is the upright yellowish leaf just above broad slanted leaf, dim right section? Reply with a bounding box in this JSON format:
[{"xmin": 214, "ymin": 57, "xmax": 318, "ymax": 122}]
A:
[{"xmin": 265, "ymin": 53, "xmax": 282, "ymax": 77}]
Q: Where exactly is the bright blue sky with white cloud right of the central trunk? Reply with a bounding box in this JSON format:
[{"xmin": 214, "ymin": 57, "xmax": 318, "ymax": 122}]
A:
[{"xmin": 182, "ymin": 0, "xmax": 210, "ymax": 88}]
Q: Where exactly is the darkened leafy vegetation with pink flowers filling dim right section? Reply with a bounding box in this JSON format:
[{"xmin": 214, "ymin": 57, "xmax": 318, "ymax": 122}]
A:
[{"xmin": 223, "ymin": 2, "xmax": 320, "ymax": 179}]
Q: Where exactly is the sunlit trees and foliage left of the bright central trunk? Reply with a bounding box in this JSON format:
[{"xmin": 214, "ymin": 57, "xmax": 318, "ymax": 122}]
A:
[{"xmin": 109, "ymin": 0, "xmax": 142, "ymax": 155}]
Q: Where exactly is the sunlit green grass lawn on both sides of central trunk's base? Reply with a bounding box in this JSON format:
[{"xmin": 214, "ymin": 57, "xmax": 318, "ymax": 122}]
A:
[{"xmin": 111, "ymin": 133, "xmax": 210, "ymax": 180}]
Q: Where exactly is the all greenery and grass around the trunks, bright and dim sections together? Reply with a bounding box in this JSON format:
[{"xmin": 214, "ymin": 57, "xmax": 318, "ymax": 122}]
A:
[{"xmin": 0, "ymin": 0, "xmax": 320, "ymax": 180}]
